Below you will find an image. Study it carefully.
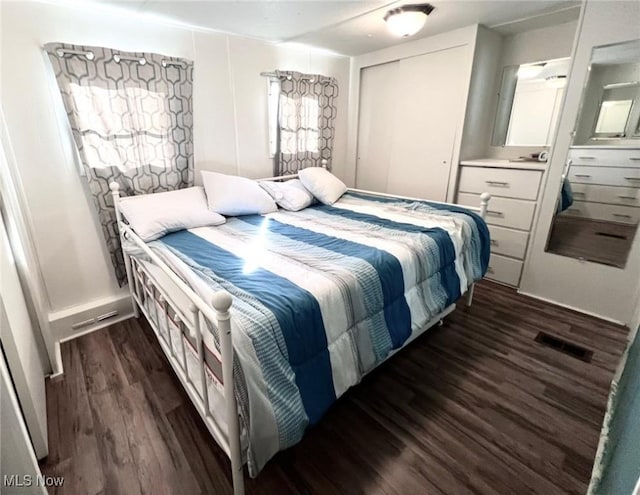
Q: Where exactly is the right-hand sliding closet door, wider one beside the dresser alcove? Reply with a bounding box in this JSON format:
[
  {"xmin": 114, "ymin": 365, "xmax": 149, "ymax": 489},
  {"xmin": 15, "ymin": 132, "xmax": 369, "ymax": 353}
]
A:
[{"xmin": 387, "ymin": 46, "xmax": 468, "ymax": 201}]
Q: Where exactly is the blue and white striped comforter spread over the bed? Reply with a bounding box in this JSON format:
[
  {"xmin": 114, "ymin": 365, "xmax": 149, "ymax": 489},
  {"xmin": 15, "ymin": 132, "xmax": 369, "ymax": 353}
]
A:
[{"xmin": 150, "ymin": 193, "xmax": 489, "ymax": 476}]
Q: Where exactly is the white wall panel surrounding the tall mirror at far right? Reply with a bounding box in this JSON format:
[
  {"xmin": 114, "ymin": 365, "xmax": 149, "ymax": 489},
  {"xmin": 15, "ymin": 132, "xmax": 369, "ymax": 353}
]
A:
[{"xmin": 520, "ymin": 0, "xmax": 640, "ymax": 324}]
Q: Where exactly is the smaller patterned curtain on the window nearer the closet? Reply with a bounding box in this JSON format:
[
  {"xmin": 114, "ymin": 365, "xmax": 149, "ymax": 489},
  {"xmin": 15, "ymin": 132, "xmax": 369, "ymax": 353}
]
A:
[{"xmin": 275, "ymin": 71, "xmax": 338, "ymax": 175}]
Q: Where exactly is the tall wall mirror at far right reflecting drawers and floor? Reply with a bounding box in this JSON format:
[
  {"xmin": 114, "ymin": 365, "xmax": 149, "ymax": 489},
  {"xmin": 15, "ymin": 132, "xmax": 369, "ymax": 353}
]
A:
[{"xmin": 547, "ymin": 40, "xmax": 640, "ymax": 268}]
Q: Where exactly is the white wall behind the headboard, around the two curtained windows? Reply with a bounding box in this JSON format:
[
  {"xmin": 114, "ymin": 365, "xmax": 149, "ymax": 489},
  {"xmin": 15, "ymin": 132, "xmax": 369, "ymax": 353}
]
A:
[{"xmin": 0, "ymin": 1, "xmax": 349, "ymax": 352}]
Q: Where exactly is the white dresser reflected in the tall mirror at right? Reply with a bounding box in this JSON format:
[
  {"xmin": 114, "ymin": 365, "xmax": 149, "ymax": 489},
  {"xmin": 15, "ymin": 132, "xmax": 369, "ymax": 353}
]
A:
[{"xmin": 563, "ymin": 146, "xmax": 640, "ymax": 225}]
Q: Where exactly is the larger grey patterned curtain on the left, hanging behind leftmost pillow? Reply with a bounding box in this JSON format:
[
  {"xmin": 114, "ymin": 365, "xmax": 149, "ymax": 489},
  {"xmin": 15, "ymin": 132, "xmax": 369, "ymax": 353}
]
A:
[{"xmin": 44, "ymin": 43, "xmax": 193, "ymax": 286}]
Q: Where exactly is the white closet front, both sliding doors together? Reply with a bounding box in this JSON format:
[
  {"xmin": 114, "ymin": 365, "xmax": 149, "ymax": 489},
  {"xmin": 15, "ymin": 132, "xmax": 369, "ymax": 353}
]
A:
[{"xmin": 356, "ymin": 45, "xmax": 468, "ymax": 201}]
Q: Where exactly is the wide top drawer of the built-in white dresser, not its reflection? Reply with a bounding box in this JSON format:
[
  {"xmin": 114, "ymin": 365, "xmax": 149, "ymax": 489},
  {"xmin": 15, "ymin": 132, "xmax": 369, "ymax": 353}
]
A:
[{"xmin": 458, "ymin": 166, "xmax": 542, "ymax": 200}]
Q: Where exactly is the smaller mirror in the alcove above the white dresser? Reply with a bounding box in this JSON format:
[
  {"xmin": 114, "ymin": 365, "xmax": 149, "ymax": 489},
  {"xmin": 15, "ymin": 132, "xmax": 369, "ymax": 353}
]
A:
[{"xmin": 491, "ymin": 58, "xmax": 570, "ymax": 146}]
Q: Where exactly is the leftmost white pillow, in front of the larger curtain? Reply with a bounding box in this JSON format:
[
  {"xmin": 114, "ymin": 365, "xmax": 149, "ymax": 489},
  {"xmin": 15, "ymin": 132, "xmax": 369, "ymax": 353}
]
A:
[{"xmin": 118, "ymin": 187, "xmax": 225, "ymax": 242}]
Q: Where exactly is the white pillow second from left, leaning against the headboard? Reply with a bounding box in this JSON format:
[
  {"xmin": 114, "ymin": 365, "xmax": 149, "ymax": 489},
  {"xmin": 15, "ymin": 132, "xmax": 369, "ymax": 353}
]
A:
[{"xmin": 202, "ymin": 170, "xmax": 278, "ymax": 216}]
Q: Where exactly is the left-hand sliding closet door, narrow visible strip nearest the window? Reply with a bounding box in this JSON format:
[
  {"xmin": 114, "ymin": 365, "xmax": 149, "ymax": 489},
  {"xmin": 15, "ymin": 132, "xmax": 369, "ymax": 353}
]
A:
[{"xmin": 356, "ymin": 60, "xmax": 400, "ymax": 192}]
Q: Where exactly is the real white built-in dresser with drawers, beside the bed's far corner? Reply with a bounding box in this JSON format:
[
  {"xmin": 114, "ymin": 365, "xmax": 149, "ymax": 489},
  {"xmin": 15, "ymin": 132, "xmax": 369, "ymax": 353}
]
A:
[{"xmin": 457, "ymin": 159, "xmax": 546, "ymax": 287}]
